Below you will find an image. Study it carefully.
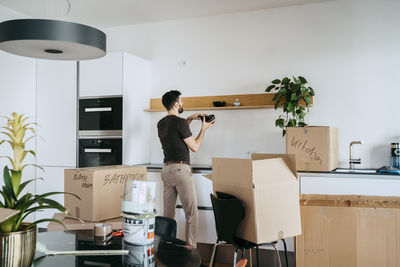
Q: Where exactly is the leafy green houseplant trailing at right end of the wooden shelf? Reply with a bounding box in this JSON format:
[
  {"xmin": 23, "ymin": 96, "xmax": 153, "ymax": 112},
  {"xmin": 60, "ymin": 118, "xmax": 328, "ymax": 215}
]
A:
[{"xmin": 265, "ymin": 76, "xmax": 314, "ymax": 136}]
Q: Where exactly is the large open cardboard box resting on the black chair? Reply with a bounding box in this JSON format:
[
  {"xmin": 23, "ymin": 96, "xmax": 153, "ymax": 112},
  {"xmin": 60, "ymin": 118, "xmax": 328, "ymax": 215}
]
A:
[{"xmin": 212, "ymin": 154, "xmax": 301, "ymax": 244}]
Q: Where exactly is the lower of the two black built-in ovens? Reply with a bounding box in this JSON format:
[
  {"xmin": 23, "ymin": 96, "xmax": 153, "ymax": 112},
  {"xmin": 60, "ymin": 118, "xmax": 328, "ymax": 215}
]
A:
[{"xmin": 78, "ymin": 136, "xmax": 122, "ymax": 167}]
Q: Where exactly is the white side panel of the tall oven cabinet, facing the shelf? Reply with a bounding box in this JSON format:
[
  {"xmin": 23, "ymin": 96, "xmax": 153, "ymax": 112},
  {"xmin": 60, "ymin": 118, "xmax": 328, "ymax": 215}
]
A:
[{"xmin": 122, "ymin": 53, "xmax": 151, "ymax": 165}]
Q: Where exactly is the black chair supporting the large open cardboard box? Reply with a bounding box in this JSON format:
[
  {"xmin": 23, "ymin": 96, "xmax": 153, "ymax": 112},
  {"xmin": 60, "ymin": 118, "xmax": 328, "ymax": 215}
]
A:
[{"xmin": 210, "ymin": 192, "xmax": 286, "ymax": 267}]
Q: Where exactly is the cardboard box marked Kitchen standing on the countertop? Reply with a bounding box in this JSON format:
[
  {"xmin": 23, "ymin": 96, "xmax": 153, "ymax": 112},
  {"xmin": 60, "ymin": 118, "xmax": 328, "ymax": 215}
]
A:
[{"xmin": 286, "ymin": 126, "xmax": 339, "ymax": 171}]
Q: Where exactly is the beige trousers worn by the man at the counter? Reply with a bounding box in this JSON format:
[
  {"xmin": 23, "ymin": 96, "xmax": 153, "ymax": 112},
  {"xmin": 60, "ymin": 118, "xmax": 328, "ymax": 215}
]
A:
[{"xmin": 161, "ymin": 163, "xmax": 199, "ymax": 247}]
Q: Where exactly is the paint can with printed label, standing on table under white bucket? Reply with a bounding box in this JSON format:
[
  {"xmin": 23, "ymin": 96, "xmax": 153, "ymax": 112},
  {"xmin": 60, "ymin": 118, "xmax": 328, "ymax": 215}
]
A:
[{"xmin": 121, "ymin": 212, "xmax": 156, "ymax": 245}]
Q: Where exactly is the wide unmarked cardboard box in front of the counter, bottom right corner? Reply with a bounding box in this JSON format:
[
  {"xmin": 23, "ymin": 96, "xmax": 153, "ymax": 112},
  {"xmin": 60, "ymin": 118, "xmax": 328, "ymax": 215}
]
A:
[{"xmin": 296, "ymin": 195, "xmax": 400, "ymax": 267}]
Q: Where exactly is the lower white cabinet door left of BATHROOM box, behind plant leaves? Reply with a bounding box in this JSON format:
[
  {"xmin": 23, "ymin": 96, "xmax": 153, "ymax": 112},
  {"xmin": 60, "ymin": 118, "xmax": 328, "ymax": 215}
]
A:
[{"xmin": 36, "ymin": 167, "xmax": 65, "ymax": 228}]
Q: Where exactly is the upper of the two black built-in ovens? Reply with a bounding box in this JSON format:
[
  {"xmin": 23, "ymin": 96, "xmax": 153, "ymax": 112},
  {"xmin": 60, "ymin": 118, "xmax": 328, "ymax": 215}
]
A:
[{"xmin": 79, "ymin": 96, "xmax": 123, "ymax": 136}]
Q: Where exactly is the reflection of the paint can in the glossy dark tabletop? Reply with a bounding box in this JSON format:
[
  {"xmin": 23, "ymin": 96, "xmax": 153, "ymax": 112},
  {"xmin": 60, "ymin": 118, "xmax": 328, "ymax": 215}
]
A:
[{"xmin": 122, "ymin": 242, "xmax": 155, "ymax": 267}]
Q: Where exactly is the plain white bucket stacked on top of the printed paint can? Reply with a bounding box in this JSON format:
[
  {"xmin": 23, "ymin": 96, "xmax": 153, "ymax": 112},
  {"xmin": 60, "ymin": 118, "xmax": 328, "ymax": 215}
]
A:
[{"xmin": 121, "ymin": 180, "xmax": 156, "ymax": 214}]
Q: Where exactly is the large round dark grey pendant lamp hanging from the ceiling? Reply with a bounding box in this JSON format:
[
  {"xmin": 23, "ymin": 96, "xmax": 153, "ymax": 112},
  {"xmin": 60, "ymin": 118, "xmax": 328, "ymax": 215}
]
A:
[{"xmin": 0, "ymin": 19, "xmax": 106, "ymax": 60}]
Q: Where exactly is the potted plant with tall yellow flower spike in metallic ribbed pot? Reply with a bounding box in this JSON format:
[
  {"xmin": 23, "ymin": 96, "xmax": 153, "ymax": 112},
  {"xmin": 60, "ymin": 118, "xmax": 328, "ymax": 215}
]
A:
[{"xmin": 0, "ymin": 113, "xmax": 78, "ymax": 266}]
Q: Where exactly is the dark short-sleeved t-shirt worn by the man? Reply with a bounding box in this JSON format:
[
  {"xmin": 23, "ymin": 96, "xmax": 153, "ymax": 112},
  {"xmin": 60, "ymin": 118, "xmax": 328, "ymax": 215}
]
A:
[{"xmin": 157, "ymin": 115, "xmax": 192, "ymax": 163}]
